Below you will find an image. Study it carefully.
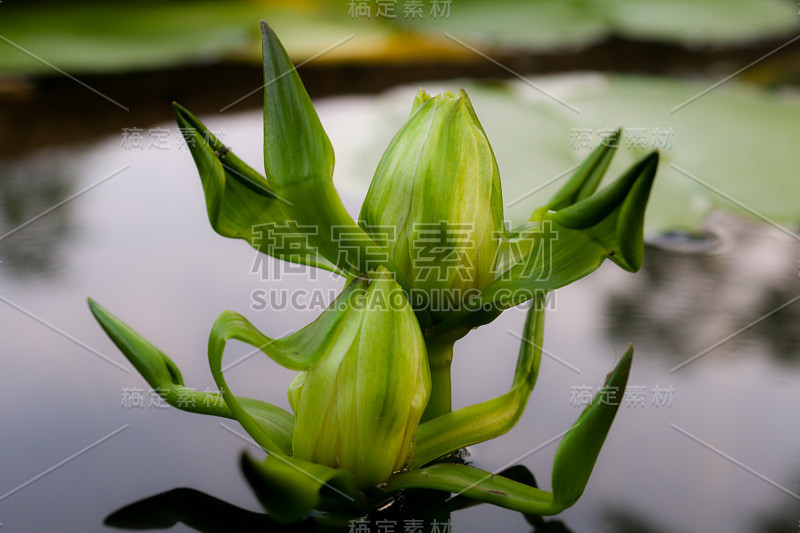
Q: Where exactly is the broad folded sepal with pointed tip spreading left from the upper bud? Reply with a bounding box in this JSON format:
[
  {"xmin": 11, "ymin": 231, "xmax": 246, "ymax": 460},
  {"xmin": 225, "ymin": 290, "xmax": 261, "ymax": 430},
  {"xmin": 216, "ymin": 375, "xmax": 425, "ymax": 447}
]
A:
[{"xmin": 173, "ymin": 104, "xmax": 385, "ymax": 276}]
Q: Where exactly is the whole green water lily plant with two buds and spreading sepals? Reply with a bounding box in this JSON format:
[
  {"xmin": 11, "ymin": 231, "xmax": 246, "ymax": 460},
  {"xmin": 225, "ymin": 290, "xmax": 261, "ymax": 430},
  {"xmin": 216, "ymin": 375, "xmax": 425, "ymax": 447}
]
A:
[{"xmin": 89, "ymin": 20, "xmax": 658, "ymax": 522}]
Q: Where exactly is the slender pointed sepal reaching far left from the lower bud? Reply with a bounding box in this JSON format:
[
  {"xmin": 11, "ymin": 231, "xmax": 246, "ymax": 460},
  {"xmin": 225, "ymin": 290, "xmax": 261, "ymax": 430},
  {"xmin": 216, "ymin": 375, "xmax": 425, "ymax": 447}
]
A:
[{"xmin": 89, "ymin": 299, "xmax": 294, "ymax": 454}]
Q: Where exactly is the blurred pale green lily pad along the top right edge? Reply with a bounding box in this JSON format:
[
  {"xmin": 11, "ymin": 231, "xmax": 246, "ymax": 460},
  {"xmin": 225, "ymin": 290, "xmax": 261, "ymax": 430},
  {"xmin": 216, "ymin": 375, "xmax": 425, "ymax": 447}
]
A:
[{"xmin": 396, "ymin": 0, "xmax": 798, "ymax": 48}]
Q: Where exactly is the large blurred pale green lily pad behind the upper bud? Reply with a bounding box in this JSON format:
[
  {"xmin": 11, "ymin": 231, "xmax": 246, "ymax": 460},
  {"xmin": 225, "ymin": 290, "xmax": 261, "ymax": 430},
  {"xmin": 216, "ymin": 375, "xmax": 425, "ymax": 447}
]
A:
[{"xmin": 328, "ymin": 74, "xmax": 800, "ymax": 235}]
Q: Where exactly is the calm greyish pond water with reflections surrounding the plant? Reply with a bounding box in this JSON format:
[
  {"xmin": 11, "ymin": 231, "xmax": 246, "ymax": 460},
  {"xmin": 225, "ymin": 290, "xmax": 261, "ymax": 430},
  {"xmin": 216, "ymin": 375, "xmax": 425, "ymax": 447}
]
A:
[{"xmin": 0, "ymin": 98, "xmax": 800, "ymax": 533}]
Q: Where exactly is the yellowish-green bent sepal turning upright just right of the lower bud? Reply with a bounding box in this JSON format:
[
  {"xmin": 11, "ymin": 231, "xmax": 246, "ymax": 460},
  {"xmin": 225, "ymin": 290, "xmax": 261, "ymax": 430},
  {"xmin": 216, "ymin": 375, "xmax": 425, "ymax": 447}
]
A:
[{"xmin": 411, "ymin": 295, "xmax": 545, "ymax": 468}]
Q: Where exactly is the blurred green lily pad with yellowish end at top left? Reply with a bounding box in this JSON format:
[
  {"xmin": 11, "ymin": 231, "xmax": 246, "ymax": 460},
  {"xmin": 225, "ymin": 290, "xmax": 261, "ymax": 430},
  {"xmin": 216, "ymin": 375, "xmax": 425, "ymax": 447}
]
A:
[{"xmin": 0, "ymin": 0, "xmax": 386, "ymax": 74}]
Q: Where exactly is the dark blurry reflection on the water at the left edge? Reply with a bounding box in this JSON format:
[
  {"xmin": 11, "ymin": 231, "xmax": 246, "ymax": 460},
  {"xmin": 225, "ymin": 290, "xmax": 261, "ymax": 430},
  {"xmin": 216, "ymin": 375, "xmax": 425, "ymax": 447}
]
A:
[{"xmin": 0, "ymin": 148, "xmax": 73, "ymax": 279}]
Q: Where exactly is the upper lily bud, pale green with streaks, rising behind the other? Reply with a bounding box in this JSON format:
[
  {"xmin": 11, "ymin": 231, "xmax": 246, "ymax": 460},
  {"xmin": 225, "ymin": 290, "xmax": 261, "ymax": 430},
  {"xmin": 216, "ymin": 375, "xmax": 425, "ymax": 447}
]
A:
[{"xmin": 359, "ymin": 90, "xmax": 503, "ymax": 312}]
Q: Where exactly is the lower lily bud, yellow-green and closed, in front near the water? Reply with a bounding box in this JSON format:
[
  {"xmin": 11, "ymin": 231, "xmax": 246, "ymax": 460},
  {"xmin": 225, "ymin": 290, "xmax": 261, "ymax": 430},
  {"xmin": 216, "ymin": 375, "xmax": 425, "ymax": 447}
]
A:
[{"xmin": 289, "ymin": 269, "xmax": 431, "ymax": 487}]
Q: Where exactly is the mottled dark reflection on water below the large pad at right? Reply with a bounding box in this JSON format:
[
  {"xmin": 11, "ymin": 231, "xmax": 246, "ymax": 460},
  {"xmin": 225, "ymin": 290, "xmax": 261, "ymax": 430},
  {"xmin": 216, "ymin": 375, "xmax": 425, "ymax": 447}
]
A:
[{"xmin": 604, "ymin": 214, "xmax": 800, "ymax": 363}]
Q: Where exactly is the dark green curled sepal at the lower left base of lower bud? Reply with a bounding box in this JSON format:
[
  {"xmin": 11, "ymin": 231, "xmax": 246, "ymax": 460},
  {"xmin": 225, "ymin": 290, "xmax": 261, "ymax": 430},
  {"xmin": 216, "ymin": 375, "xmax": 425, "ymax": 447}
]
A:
[{"xmin": 241, "ymin": 455, "xmax": 363, "ymax": 523}]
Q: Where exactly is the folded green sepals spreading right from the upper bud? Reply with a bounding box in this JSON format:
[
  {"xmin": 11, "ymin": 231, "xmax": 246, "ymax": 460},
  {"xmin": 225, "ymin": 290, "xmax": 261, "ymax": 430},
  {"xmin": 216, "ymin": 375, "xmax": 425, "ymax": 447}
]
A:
[{"xmin": 431, "ymin": 146, "xmax": 658, "ymax": 334}]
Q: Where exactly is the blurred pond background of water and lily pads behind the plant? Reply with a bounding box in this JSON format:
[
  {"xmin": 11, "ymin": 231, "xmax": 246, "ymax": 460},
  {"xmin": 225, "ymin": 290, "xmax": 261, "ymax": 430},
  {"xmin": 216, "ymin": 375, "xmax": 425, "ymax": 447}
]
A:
[{"xmin": 0, "ymin": 0, "xmax": 800, "ymax": 533}]
